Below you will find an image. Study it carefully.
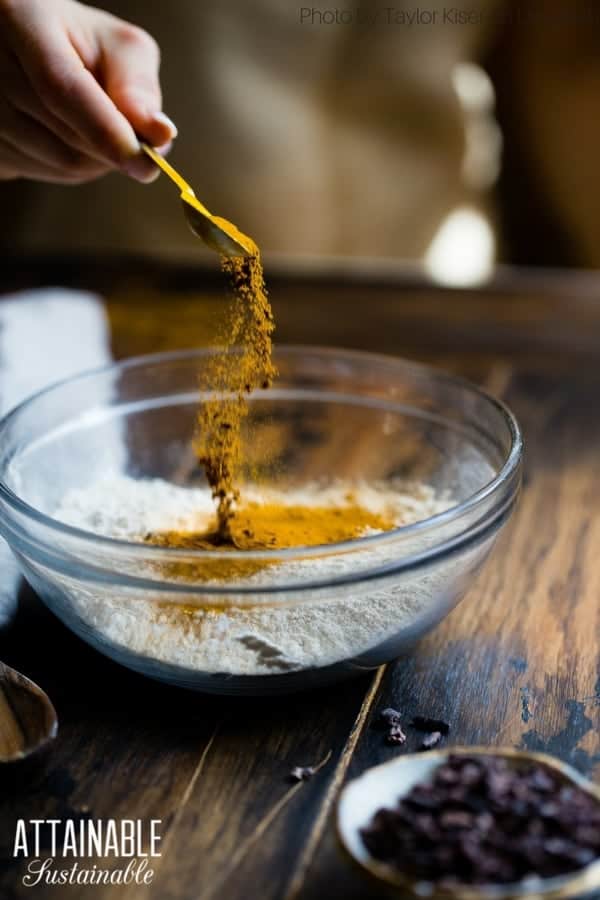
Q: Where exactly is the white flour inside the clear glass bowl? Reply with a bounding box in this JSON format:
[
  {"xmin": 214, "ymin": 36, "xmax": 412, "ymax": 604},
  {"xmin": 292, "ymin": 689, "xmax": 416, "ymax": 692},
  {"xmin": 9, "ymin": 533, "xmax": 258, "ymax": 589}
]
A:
[{"xmin": 54, "ymin": 476, "xmax": 466, "ymax": 675}]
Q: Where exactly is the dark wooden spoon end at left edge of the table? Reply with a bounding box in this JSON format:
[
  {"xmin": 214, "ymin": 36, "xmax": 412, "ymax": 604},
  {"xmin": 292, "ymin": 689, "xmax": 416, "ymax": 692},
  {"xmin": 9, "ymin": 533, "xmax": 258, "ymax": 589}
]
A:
[{"xmin": 0, "ymin": 662, "xmax": 58, "ymax": 767}]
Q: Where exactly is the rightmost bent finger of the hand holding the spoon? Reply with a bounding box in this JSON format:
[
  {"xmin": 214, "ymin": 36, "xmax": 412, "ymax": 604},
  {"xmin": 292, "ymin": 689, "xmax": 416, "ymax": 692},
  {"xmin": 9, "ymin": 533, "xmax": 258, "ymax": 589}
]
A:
[{"xmin": 100, "ymin": 20, "xmax": 177, "ymax": 147}]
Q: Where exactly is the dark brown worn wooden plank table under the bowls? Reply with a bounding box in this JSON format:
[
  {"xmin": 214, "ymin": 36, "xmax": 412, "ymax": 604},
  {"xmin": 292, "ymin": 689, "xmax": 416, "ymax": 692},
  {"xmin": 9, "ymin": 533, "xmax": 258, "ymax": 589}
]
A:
[{"xmin": 0, "ymin": 262, "xmax": 600, "ymax": 900}]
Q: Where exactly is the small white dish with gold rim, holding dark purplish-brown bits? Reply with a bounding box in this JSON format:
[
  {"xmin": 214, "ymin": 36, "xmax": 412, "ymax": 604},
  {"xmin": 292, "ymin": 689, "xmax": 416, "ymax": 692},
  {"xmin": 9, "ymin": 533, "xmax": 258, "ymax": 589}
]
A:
[{"xmin": 337, "ymin": 747, "xmax": 600, "ymax": 900}]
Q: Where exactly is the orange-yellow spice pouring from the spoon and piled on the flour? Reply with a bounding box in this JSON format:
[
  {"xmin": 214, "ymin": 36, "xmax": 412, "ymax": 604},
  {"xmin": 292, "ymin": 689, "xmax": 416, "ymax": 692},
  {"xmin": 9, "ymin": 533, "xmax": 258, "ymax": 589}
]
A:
[{"xmin": 144, "ymin": 216, "xmax": 395, "ymax": 568}]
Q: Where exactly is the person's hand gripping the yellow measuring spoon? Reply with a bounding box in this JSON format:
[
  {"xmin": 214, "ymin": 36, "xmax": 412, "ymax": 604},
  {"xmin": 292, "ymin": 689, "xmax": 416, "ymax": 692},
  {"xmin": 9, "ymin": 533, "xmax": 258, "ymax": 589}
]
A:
[{"xmin": 0, "ymin": 0, "xmax": 177, "ymax": 184}]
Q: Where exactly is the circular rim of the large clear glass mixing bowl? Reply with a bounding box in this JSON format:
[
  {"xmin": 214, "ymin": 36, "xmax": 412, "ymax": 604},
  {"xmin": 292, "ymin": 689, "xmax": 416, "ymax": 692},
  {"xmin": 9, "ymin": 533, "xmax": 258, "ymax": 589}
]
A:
[{"xmin": 0, "ymin": 344, "xmax": 524, "ymax": 564}]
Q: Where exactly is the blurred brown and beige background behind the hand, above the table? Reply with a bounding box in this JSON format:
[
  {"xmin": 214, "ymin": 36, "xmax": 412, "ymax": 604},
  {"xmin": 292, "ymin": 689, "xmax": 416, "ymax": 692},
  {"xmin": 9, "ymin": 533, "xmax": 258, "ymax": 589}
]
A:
[{"xmin": 0, "ymin": 0, "xmax": 600, "ymax": 286}]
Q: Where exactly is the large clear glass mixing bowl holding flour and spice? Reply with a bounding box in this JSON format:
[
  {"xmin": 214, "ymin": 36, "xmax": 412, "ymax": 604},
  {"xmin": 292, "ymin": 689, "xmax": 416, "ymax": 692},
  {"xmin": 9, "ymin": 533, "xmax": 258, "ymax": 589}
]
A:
[{"xmin": 0, "ymin": 347, "xmax": 522, "ymax": 694}]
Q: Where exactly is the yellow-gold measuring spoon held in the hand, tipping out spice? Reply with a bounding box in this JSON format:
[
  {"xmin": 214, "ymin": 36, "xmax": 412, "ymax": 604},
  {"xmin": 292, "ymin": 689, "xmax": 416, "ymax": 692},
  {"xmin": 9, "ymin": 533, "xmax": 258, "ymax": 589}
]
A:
[{"xmin": 140, "ymin": 143, "xmax": 254, "ymax": 257}]
